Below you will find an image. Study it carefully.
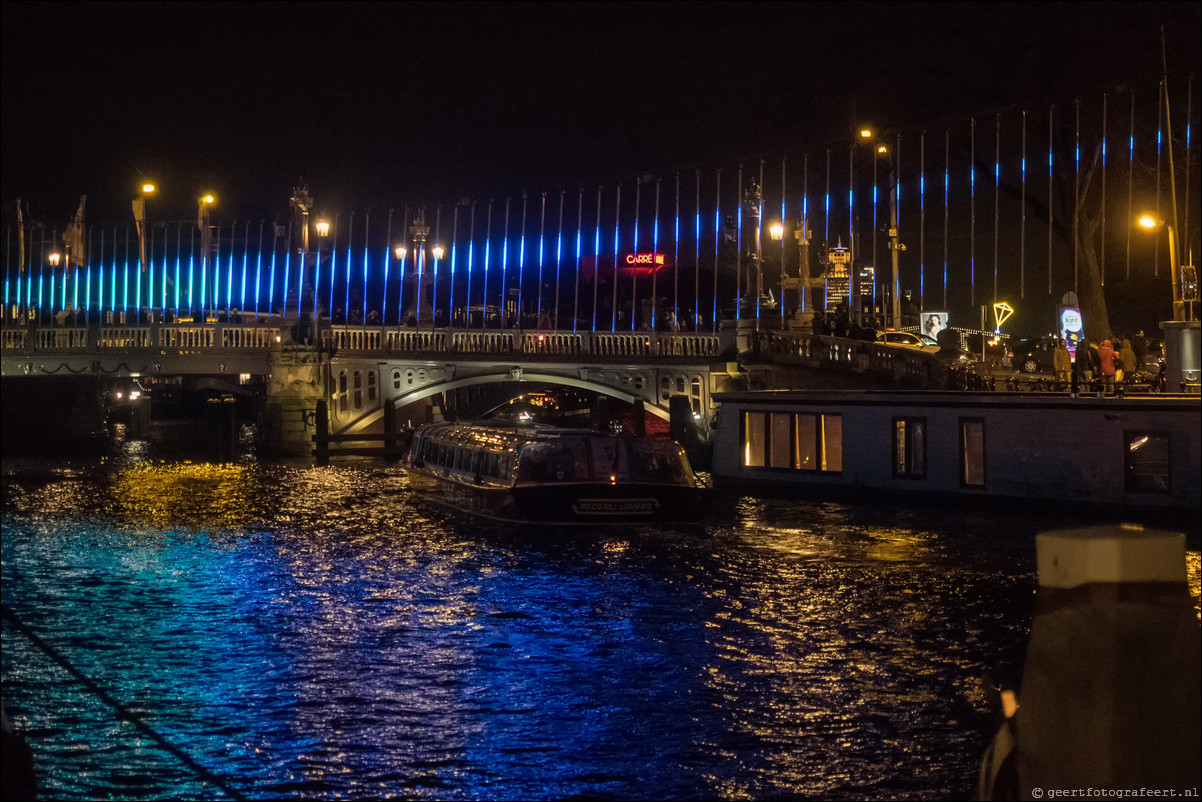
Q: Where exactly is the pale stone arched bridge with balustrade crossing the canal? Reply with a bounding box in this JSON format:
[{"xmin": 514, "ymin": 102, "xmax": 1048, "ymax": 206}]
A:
[{"xmin": 0, "ymin": 317, "xmax": 952, "ymax": 455}]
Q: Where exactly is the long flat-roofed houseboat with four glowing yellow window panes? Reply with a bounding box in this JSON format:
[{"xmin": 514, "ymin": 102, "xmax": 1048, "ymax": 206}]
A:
[{"xmin": 710, "ymin": 391, "xmax": 1202, "ymax": 516}]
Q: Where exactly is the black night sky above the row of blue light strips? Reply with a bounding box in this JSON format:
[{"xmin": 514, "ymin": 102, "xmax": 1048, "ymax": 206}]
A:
[{"xmin": 0, "ymin": 2, "xmax": 1200, "ymax": 224}]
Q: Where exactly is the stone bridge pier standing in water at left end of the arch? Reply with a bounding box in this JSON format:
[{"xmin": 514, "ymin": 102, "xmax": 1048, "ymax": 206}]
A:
[{"xmin": 263, "ymin": 345, "xmax": 327, "ymax": 457}]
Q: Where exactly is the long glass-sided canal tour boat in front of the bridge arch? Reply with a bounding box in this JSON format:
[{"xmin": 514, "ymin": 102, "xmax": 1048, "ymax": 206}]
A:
[{"xmin": 406, "ymin": 421, "xmax": 708, "ymax": 525}]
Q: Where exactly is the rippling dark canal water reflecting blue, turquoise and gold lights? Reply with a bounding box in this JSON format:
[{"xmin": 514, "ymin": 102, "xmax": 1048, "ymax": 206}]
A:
[{"xmin": 2, "ymin": 422, "xmax": 1198, "ymax": 800}]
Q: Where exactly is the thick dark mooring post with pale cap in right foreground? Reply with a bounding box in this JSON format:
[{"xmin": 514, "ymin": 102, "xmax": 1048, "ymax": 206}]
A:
[{"xmin": 1014, "ymin": 527, "xmax": 1202, "ymax": 800}]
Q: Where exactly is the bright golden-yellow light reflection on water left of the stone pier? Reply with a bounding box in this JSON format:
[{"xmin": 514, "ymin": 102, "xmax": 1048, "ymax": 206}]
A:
[{"xmin": 112, "ymin": 463, "xmax": 257, "ymax": 529}]
